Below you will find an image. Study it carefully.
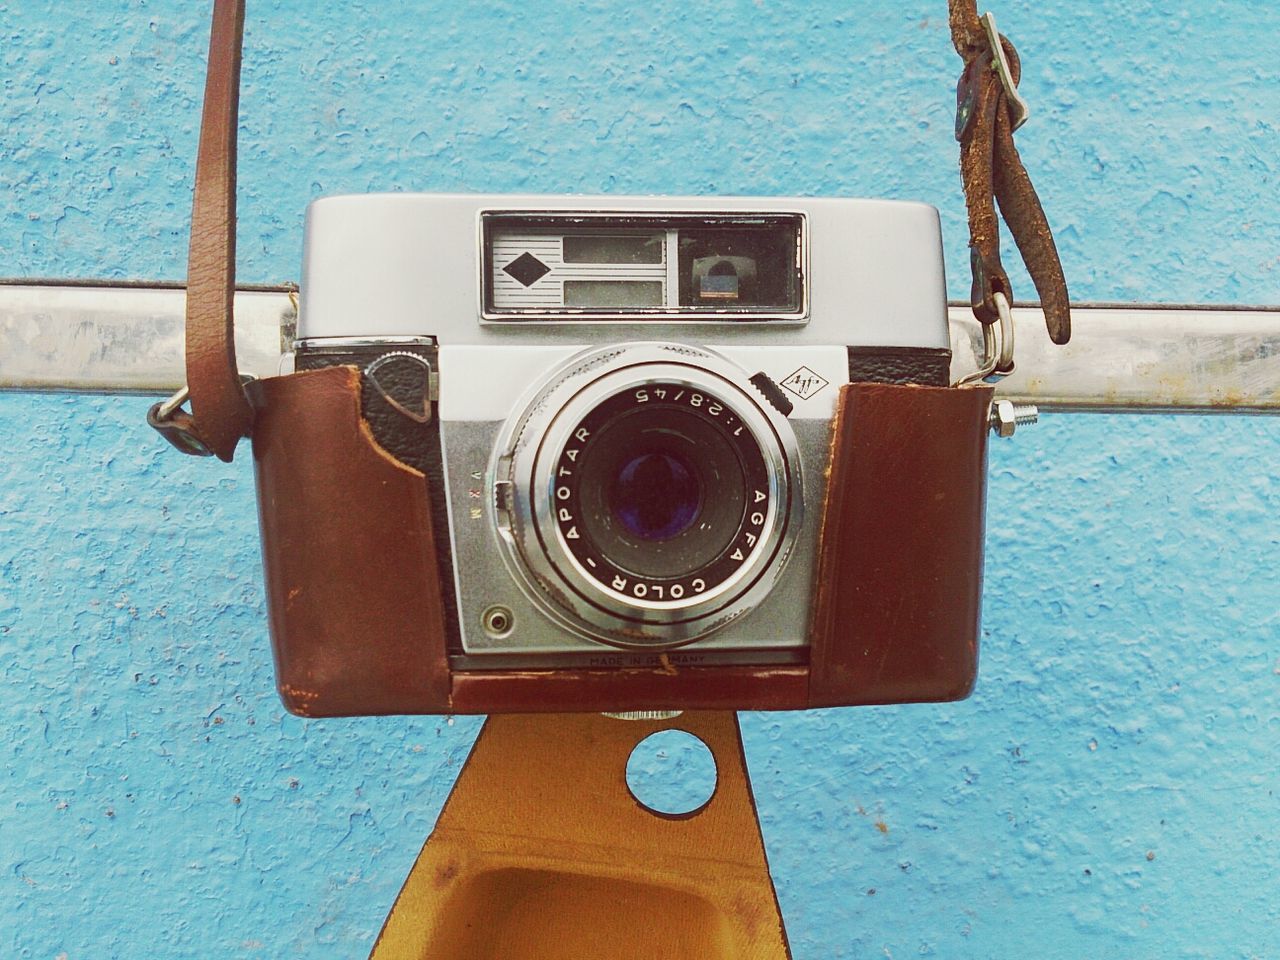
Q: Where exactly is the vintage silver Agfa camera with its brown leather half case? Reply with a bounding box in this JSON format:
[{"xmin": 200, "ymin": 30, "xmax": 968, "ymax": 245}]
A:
[{"xmin": 255, "ymin": 195, "xmax": 989, "ymax": 714}]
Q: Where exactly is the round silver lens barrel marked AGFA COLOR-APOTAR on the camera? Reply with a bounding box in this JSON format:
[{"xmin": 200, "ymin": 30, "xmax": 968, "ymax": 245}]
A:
[{"xmin": 490, "ymin": 343, "xmax": 803, "ymax": 648}]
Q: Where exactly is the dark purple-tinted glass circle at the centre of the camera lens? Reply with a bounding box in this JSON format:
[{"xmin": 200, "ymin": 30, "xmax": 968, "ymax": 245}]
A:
[{"xmin": 609, "ymin": 451, "xmax": 703, "ymax": 540}]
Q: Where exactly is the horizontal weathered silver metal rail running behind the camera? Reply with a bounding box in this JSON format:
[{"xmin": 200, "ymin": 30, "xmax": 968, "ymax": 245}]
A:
[{"xmin": 0, "ymin": 282, "xmax": 1280, "ymax": 413}]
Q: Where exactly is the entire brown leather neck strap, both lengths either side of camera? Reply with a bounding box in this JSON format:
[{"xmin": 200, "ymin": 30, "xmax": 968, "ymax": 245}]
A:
[{"xmin": 165, "ymin": 0, "xmax": 1071, "ymax": 461}]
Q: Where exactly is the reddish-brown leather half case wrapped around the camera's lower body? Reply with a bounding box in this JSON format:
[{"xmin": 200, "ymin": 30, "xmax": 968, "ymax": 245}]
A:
[{"xmin": 248, "ymin": 367, "xmax": 992, "ymax": 717}]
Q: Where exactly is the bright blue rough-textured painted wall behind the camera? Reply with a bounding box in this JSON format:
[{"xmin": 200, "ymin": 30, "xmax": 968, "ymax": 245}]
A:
[{"xmin": 0, "ymin": 0, "xmax": 1280, "ymax": 960}]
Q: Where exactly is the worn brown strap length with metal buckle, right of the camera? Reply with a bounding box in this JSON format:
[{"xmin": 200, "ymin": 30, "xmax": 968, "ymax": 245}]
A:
[{"xmin": 948, "ymin": 0, "xmax": 1071, "ymax": 343}]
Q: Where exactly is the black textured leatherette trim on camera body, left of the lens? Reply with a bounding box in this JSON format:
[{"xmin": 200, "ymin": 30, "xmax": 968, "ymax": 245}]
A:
[{"xmin": 294, "ymin": 343, "xmax": 461, "ymax": 649}]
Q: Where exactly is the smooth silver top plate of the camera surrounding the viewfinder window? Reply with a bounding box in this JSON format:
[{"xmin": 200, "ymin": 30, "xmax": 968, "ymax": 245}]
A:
[{"xmin": 298, "ymin": 193, "xmax": 950, "ymax": 348}]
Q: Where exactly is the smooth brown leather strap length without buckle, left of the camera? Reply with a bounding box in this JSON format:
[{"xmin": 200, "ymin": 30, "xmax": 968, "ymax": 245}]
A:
[{"xmin": 179, "ymin": 0, "xmax": 253, "ymax": 461}]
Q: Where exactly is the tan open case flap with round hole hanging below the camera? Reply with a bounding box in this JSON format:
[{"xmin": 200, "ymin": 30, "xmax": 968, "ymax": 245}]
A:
[{"xmin": 371, "ymin": 713, "xmax": 790, "ymax": 960}]
